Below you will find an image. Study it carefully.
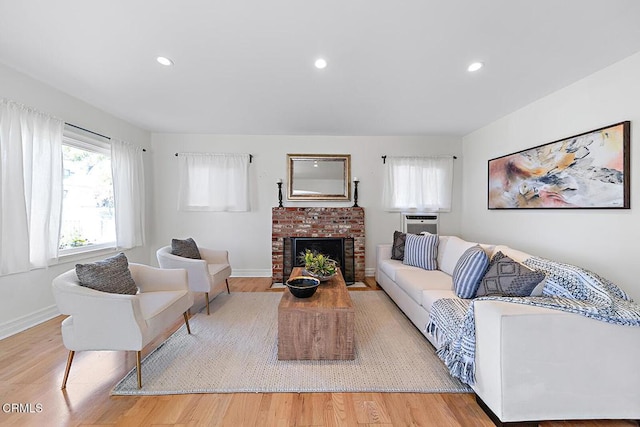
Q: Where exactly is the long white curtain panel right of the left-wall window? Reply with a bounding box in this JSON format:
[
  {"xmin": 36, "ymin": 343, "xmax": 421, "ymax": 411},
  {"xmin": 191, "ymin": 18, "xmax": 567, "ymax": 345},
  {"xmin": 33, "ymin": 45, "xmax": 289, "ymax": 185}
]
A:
[{"xmin": 111, "ymin": 138, "xmax": 145, "ymax": 249}]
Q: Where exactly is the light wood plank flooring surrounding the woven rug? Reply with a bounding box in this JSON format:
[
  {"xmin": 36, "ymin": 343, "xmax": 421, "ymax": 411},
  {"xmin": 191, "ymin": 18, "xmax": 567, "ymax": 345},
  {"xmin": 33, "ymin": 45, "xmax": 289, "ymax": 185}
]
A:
[{"xmin": 0, "ymin": 278, "xmax": 636, "ymax": 427}]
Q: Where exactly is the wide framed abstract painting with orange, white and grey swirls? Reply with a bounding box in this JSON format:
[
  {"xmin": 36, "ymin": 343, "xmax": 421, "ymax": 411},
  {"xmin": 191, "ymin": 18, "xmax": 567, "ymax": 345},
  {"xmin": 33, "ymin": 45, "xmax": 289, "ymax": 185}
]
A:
[{"xmin": 487, "ymin": 121, "xmax": 631, "ymax": 209}]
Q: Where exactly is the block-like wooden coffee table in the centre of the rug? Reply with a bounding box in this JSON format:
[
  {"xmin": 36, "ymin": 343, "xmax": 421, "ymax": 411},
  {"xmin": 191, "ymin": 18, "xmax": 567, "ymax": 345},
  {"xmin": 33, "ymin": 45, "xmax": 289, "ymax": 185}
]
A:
[{"xmin": 278, "ymin": 267, "xmax": 356, "ymax": 360}]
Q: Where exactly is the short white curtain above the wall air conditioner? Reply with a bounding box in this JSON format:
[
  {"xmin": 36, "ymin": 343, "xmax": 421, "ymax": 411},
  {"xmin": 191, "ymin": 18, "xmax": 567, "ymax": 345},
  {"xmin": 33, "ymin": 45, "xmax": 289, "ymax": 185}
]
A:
[{"xmin": 383, "ymin": 156, "xmax": 453, "ymax": 212}]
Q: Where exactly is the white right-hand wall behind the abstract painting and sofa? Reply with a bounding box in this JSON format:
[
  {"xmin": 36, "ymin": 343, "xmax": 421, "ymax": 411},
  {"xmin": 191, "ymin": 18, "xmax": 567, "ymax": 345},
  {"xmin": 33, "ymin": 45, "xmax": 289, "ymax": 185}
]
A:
[{"xmin": 461, "ymin": 53, "xmax": 640, "ymax": 300}]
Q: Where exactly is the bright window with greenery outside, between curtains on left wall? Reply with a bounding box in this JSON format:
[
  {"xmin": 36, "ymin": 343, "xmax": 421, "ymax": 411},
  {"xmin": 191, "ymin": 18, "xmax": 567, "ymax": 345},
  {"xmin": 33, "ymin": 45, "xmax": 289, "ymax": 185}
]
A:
[{"xmin": 59, "ymin": 127, "xmax": 116, "ymax": 255}]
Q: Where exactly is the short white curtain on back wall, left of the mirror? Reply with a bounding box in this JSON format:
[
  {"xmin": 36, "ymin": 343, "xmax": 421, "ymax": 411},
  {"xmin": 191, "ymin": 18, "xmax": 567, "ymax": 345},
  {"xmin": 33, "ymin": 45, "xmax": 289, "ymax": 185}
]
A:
[{"xmin": 178, "ymin": 153, "xmax": 249, "ymax": 212}]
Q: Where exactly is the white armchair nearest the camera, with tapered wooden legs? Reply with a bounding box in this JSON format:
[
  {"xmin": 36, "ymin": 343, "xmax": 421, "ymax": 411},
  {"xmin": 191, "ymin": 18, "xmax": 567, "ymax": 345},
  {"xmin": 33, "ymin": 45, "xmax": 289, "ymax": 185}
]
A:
[{"xmin": 52, "ymin": 263, "xmax": 193, "ymax": 389}]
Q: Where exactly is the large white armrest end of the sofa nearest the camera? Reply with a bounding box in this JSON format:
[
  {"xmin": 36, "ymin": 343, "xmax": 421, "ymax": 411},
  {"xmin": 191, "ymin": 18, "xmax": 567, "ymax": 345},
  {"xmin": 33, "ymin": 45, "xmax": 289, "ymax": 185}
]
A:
[{"xmin": 473, "ymin": 301, "xmax": 640, "ymax": 422}]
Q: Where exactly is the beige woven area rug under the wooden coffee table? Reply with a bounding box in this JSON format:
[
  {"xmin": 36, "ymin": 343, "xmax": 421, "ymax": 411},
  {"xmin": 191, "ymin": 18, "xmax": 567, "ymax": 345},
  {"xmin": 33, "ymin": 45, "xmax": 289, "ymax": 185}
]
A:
[{"xmin": 112, "ymin": 291, "xmax": 471, "ymax": 395}]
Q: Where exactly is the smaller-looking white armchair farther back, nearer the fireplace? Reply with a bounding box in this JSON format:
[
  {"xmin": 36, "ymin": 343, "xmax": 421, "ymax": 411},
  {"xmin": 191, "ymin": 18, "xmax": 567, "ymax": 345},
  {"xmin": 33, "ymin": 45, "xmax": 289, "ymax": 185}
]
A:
[{"xmin": 156, "ymin": 246, "xmax": 231, "ymax": 314}]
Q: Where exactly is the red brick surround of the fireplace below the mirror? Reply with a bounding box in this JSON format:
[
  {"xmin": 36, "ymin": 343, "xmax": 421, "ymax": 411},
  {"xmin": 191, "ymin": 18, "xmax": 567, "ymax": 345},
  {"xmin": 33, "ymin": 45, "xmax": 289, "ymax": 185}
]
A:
[{"xmin": 271, "ymin": 207, "xmax": 365, "ymax": 283}]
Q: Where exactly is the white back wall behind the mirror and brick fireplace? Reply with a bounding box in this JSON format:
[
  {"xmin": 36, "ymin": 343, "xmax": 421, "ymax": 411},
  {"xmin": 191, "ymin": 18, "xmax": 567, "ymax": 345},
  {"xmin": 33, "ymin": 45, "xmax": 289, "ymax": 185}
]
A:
[{"xmin": 151, "ymin": 134, "xmax": 462, "ymax": 277}]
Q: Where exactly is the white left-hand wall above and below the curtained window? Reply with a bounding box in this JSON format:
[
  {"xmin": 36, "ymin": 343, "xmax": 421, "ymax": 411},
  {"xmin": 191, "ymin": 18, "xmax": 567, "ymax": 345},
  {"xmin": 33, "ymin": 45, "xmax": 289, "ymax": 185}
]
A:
[{"xmin": 0, "ymin": 64, "xmax": 153, "ymax": 338}]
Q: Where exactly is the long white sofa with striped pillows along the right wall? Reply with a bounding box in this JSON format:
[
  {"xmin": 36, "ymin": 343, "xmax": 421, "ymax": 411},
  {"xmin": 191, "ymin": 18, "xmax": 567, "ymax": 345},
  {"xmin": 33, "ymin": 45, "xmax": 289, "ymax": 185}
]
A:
[{"xmin": 376, "ymin": 236, "xmax": 640, "ymax": 424}]
